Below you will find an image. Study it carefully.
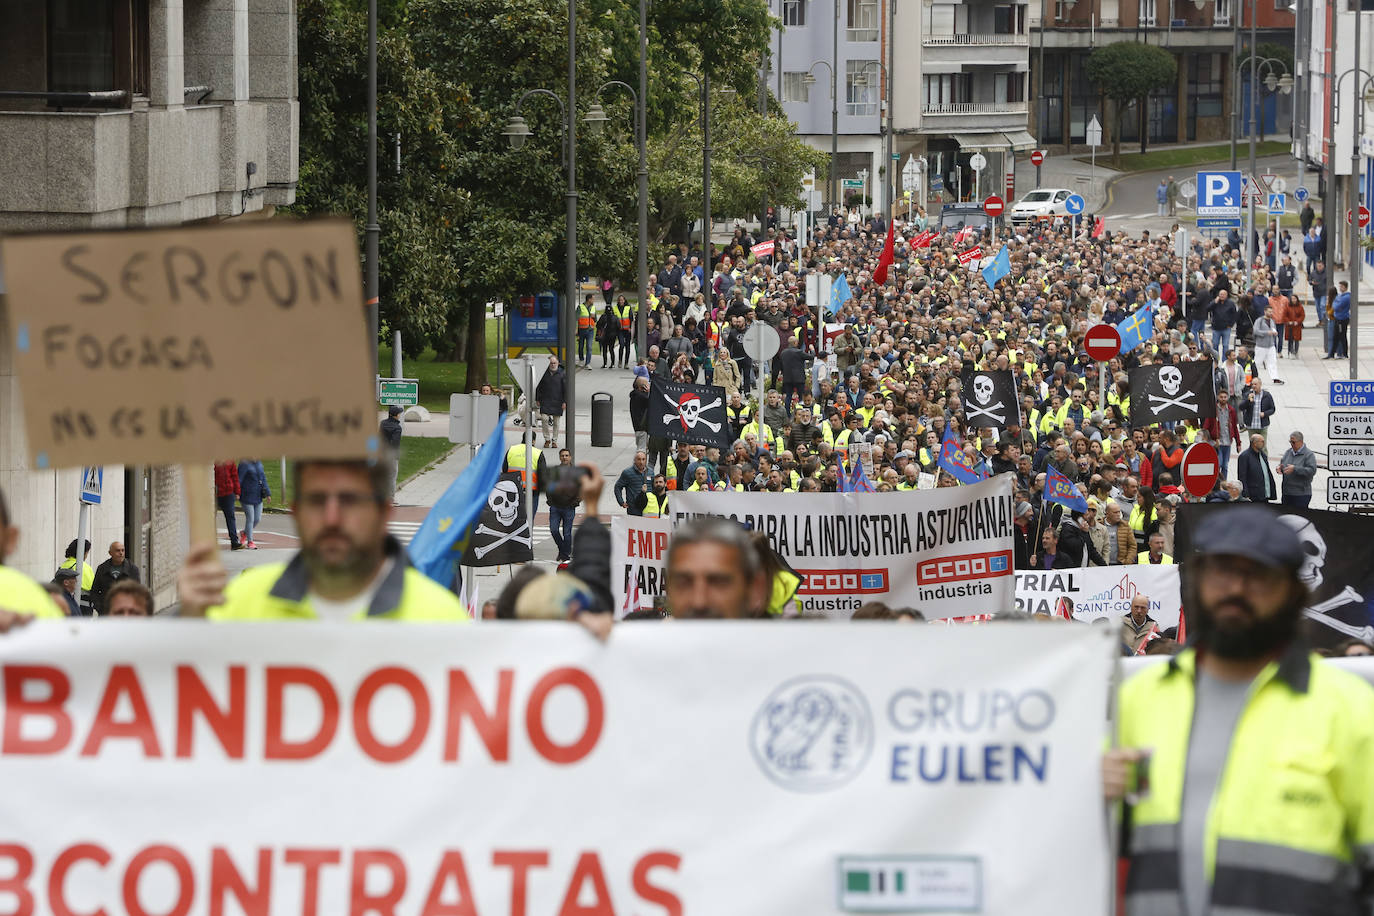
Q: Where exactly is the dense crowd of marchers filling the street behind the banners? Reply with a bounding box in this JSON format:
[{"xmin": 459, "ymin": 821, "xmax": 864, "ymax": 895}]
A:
[{"xmin": 616, "ymin": 204, "xmax": 1342, "ymax": 567}]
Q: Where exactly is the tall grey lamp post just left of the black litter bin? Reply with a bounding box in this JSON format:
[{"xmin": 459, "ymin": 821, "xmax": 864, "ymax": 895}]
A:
[{"xmin": 502, "ymin": 0, "xmax": 577, "ymax": 460}]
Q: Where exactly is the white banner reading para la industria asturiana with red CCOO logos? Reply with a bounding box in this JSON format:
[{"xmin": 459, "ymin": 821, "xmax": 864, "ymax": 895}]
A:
[{"xmin": 669, "ymin": 474, "xmax": 1014, "ymax": 619}]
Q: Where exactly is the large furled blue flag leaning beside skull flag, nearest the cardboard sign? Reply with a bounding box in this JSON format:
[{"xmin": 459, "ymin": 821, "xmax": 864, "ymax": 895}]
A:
[{"xmin": 409, "ymin": 413, "xmax": 506, "ymax": 588}]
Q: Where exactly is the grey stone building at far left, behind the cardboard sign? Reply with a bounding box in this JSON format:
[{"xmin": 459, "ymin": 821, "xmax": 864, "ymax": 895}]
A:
[{"xmin": 0, "ymin": 0, "xmax": 300, "ymax": 607}]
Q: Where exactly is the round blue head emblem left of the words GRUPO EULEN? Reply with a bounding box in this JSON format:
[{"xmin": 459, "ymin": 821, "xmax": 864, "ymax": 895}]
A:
[{"xmin": 749, "ymin": 674, "xmax": 872, "ymax": 792}]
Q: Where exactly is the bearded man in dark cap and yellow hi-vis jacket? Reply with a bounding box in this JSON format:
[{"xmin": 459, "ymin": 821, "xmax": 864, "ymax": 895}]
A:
[{"xmin": 1103, "ymin": 505, "xmax": 1374, "ymax": 916}]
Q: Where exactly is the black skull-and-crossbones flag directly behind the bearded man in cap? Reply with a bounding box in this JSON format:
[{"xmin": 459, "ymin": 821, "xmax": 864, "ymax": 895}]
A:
[{"xmin": 1173, "ymin": 503, "xmax": 1374, "ymax": 648}]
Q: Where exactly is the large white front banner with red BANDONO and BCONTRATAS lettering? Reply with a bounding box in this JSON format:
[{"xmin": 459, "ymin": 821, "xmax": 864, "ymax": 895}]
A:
[{"xmin": 0, "ymin": 621, "xmax": 1112, "ymax": 916}]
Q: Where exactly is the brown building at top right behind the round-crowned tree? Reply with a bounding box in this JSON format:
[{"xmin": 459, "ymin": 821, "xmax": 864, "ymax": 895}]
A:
[{"xmin": 1031, "ymin": 0, "xmax": 1296, "ymax": 150}]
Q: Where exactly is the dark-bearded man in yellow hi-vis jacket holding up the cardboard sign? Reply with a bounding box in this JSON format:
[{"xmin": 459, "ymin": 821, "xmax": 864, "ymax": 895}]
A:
[{"xmin": 177, "ymin": 460, "xmax": 469, "ymax": 623}]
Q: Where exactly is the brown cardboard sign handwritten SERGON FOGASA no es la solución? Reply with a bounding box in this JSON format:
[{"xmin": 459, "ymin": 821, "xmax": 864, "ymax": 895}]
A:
[{"xmin": 0, "ymin": 220, "xmax": 376, "ymax": 468}]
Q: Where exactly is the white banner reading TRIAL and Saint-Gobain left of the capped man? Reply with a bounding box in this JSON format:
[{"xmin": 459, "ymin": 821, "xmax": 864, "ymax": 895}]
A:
[{"xmin": 1017, "ymin": 564, "xmax": 1183, "ymax": 630}]
